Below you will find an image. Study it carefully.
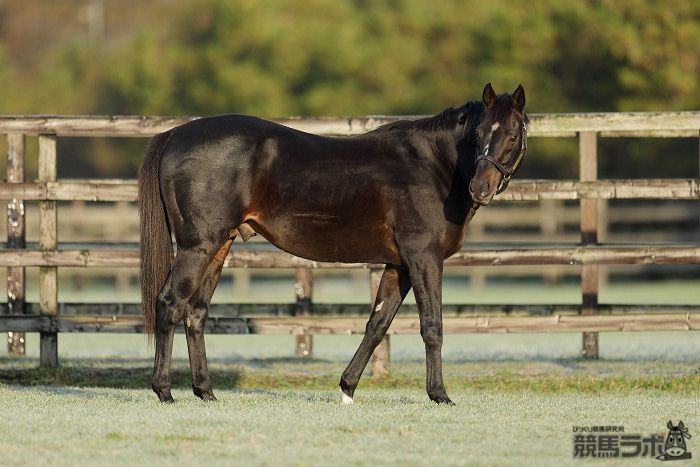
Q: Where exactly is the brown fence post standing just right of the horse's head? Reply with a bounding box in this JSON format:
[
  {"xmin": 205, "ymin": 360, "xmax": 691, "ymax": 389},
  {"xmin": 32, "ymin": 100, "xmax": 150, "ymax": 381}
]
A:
[{"xmin": 579, "ymin": 131, "xmax": 598, "ymax": 358}]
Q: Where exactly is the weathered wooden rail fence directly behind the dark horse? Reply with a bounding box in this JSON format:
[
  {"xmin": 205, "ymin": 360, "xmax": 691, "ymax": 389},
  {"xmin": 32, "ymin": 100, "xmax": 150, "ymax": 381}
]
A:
[{"xmin": 0, "ymin": 112, "xmax": 700, "ymax": 372}]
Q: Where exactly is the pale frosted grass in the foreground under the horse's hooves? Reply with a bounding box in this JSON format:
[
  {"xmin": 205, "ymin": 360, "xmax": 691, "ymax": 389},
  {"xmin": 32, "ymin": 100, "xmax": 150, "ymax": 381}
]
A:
[{"xmin": 0, "ymin": 378, "xmax": 700, "ymax": 465}]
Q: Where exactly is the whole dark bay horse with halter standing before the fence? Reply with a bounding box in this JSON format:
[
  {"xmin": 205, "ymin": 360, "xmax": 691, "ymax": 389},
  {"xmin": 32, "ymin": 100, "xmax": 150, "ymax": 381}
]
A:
[{"xmin": 139, "ymin": 83, "xmax": 527, "ymax": 404}]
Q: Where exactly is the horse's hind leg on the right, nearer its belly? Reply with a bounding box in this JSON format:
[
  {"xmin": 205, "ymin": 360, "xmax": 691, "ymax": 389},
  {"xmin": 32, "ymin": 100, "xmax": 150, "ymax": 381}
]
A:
[{"xmin": 185, "ymin": 237, "xmax": 234, "ymax": 401}]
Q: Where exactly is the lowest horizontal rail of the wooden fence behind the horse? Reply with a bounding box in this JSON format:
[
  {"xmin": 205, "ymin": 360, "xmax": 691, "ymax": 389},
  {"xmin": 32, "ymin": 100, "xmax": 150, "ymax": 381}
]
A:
[{"xmin": 0, "ymin": 313, "xmax": 700, "ymax": 335}]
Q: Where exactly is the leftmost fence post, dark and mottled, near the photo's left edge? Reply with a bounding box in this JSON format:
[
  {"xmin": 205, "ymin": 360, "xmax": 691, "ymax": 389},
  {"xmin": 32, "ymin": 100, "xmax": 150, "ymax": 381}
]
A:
[{"xmin": 7, "ymin": 134, "xmax": 26, "ymax": 355}]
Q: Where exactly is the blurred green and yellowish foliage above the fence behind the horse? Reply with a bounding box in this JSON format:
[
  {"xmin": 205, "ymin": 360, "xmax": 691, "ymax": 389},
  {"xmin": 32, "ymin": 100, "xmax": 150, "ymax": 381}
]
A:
[{"xmin": 0, "ymin": 0, "xmax": 700, "ymax": 176}]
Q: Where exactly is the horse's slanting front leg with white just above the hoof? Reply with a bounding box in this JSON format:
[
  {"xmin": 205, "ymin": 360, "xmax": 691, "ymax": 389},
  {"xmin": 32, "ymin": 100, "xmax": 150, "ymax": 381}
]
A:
[{"xmin": 340, "ymin": 265, "xmax": 411, "ymax": 404}]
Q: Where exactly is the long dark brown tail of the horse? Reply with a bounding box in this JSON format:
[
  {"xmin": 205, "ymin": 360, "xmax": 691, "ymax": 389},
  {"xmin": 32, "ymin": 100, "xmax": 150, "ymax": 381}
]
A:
[{"xmin": 138, "ymin": 131, "xmax": 173, "ymax": 342}]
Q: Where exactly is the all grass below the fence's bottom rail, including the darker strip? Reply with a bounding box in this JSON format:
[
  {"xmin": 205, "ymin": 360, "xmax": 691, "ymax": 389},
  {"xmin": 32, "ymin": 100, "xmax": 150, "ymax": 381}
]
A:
[{"xmin": 0, "ymin": 333, "xmax": 700, "ymax": 465}]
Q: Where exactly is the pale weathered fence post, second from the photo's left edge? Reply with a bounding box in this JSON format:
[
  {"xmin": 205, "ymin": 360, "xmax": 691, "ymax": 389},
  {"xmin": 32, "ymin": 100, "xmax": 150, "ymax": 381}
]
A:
[{"xmin": 39, "ymin": 135, "xmax": 58, "ymax": 368}]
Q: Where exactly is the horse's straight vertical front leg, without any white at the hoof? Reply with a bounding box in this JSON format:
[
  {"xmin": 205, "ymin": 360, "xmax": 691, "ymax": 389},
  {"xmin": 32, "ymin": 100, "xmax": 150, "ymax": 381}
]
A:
[{"xmin": 409, "ymin": 254, "xmax": 454, "ymax": 405}]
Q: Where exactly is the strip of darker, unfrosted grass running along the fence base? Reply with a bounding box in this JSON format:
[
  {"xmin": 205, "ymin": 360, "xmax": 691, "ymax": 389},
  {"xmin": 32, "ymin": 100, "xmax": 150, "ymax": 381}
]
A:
[{"xmin": 0, "ymin": 357, "xmax": 700, "ymax": 394}]
